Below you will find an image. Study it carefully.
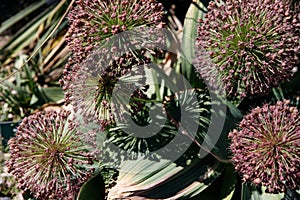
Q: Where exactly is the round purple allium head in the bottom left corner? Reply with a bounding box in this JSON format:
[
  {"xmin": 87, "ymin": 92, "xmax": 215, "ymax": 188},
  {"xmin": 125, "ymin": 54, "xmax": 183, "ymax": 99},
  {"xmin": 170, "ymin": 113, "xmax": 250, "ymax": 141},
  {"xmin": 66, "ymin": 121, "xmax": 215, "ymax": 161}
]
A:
[{"xmin": 7, "ymin": 111, "xmax": 94, "ymax": 200}]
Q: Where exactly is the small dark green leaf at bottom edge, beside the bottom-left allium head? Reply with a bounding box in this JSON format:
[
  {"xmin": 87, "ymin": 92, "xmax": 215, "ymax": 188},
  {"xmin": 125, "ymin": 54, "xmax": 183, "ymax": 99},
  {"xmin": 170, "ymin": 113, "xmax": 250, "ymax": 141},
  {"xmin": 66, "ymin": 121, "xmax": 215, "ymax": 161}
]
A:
[{"xmin": 77, "ymin": 174, "xmax": 105, "ymax": 200}]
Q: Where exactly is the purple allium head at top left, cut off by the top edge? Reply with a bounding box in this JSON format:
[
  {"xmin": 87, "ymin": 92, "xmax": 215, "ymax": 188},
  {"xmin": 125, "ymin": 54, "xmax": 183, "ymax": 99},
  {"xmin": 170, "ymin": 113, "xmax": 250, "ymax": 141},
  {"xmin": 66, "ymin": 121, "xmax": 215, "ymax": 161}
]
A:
[{"xmin": 60, "ymin": 0, "xmax": 163, "ymax": 108}]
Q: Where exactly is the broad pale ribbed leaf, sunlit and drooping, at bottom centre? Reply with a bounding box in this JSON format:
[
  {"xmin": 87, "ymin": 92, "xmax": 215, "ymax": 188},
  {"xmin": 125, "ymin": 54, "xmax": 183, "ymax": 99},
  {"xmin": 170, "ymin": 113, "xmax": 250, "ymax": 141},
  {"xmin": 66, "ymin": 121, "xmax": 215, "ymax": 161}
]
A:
[{"xmin": 108, "ymin": 155, "xmax": 224, "ymax": 199}]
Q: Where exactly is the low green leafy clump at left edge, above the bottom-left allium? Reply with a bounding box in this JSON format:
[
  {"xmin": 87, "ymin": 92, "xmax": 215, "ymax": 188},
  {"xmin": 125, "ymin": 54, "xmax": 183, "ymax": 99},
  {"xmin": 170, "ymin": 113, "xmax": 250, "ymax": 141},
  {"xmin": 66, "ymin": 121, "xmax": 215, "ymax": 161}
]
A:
[{"xmin": 0, "ymin": 55, "xmax": 63, "ymax": 121}]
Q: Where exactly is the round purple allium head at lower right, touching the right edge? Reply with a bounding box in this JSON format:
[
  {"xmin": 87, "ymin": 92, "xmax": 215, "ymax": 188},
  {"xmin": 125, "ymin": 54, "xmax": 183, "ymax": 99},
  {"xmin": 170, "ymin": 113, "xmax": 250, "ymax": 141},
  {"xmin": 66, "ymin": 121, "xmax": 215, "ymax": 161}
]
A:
[{"xmin": 229, "ymin": 100, "xmax": 300, "ymax": 193}]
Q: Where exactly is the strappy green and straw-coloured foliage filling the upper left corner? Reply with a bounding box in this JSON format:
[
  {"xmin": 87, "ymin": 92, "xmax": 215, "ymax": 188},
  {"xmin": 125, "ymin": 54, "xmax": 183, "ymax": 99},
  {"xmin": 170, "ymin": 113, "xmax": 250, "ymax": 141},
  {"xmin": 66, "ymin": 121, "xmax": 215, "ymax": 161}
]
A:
[{"xmin": 0, "ymin": 0, "xmax": 70, "ymax": 121}]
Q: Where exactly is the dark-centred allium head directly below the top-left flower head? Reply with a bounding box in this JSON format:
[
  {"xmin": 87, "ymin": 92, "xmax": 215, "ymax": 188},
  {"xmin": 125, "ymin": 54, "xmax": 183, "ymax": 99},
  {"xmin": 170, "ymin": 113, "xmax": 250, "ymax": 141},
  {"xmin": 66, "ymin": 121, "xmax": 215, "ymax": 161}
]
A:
[{"xmin": 65, "ymin": 48, "xmax": 150, "ymax": 130}]
